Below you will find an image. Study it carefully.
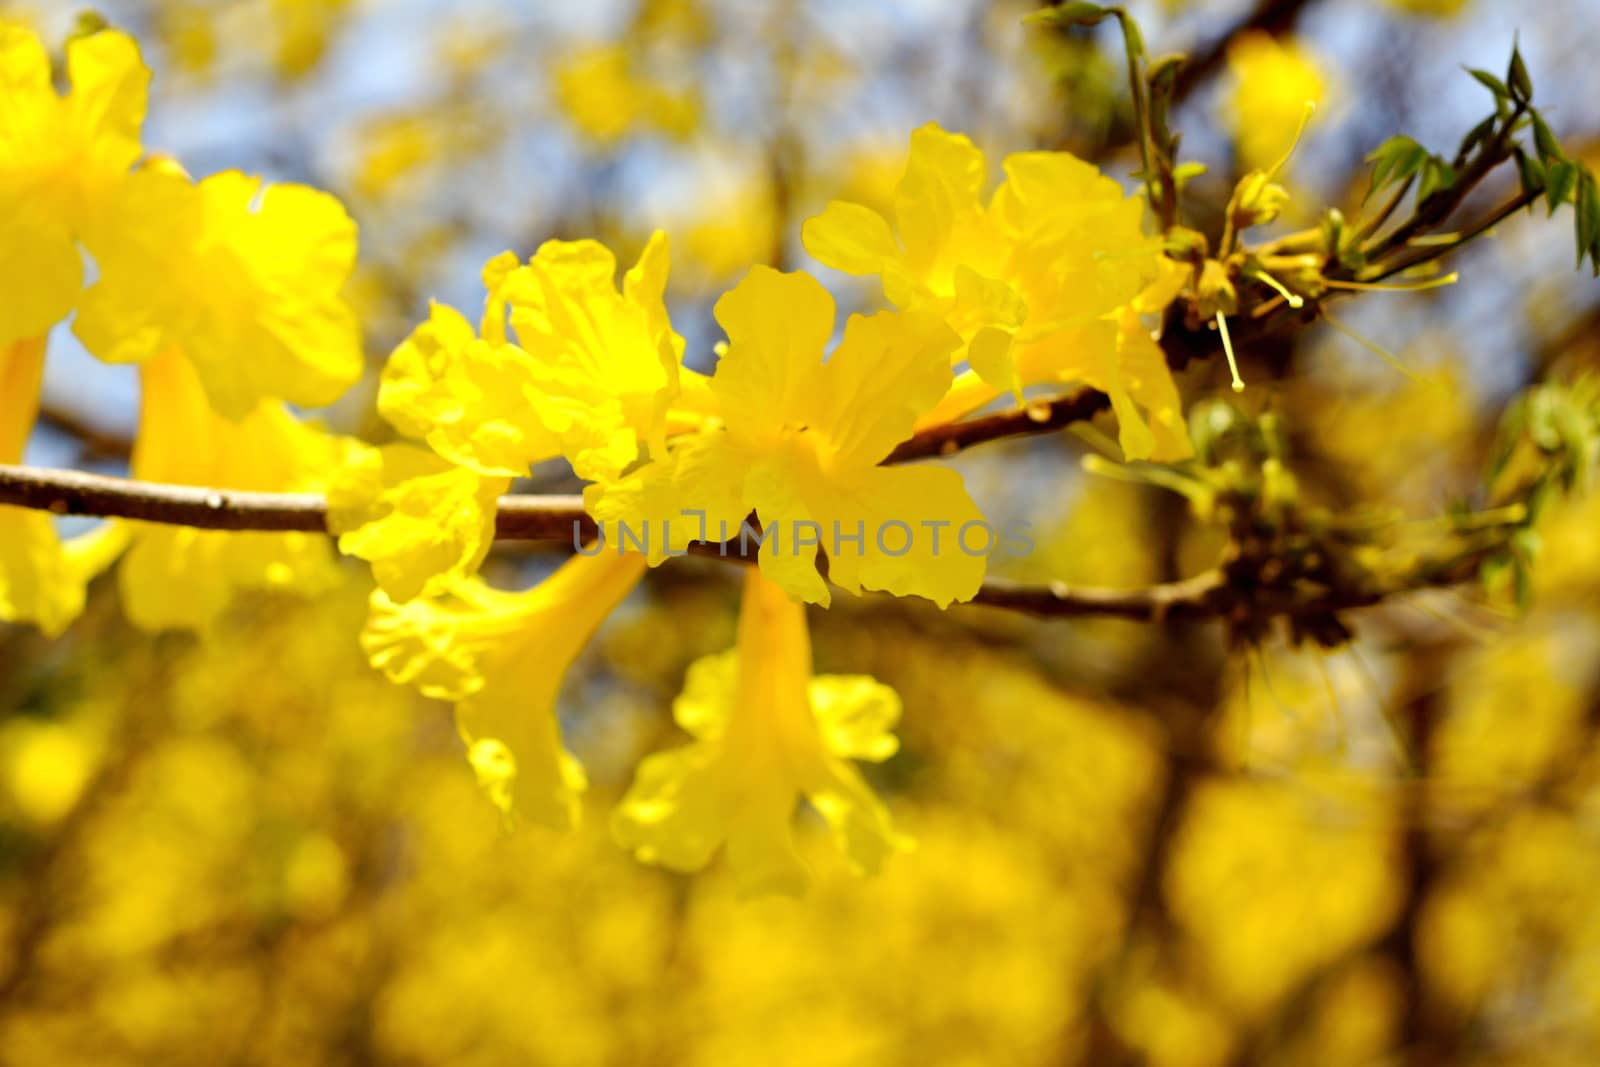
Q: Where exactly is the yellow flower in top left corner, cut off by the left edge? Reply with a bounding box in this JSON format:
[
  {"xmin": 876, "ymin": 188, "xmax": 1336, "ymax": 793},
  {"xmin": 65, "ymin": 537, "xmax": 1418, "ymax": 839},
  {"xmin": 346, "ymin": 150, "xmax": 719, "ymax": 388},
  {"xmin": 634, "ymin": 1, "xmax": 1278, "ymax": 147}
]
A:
[{"xmin": 0, "ymin": 21, "xmax": 150, "ymax": 346}]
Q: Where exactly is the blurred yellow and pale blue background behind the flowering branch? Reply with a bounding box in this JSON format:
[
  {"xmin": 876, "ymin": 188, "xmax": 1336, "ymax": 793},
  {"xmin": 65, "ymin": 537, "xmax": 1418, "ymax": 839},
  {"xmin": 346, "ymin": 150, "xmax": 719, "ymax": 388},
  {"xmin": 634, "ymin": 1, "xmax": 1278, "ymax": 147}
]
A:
[{"xmin": 0, "ymin": 0, "xmax": 1600, "ymax": 1067}]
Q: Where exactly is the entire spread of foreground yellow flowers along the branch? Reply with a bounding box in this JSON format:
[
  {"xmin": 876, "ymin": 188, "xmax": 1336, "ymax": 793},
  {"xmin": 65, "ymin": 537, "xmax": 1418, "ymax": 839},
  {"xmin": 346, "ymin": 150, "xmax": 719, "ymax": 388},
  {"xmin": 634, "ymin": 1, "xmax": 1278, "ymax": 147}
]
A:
[{"xmin": 0, "ymin": 27, "xmax": 1189, "ymax": 891}]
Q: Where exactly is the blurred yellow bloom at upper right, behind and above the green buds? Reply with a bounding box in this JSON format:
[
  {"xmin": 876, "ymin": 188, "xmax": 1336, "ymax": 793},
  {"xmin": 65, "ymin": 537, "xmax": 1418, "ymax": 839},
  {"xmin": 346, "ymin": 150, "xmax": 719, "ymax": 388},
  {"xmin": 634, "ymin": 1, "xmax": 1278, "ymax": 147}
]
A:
[{"xmin": 1227, "ymin": 30, "xmax": 1326, "ymax": 171}]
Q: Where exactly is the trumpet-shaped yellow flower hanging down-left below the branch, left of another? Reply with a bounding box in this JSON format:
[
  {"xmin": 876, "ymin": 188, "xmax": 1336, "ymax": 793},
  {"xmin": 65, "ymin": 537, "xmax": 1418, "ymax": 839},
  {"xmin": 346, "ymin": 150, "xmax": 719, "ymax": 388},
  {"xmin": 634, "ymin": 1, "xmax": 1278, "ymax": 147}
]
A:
[{"xmin": 362, "ymin": 552, "xmax": 645, "ymax": 830}]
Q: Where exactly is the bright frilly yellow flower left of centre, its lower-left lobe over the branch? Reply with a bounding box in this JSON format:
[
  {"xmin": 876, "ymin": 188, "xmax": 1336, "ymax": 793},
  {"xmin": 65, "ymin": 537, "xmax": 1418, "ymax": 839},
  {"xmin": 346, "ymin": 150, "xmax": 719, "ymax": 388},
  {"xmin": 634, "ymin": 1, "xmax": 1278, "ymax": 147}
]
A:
[{"xmin": 328, "ymin": 232, "xmax": 684, "ymax": 601}]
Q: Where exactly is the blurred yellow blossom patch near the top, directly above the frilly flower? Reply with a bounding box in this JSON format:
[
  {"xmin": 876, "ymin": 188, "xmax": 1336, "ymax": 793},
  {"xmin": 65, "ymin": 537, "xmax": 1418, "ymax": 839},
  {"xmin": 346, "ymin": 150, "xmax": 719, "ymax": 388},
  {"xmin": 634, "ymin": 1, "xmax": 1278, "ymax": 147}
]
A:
[{"xmin": 555, "ymin": 45, "xmax": 699, "ymax": 146}]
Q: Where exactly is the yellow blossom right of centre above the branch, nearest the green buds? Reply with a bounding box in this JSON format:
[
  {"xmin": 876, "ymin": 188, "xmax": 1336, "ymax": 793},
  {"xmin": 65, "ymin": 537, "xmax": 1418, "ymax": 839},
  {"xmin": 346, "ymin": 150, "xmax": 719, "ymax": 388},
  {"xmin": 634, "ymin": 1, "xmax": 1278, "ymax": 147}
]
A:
[{"xmin": 802, "ymin": 125, "xmax": 1189, "ymax": 459}]
